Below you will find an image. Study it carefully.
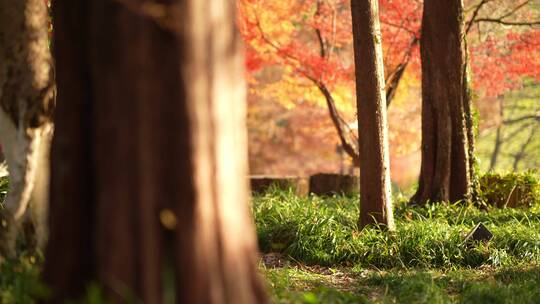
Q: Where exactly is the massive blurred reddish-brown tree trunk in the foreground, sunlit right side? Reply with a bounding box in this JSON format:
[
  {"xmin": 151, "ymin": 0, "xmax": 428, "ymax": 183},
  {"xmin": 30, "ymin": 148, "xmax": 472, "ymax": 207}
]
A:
[{"xmin": 43, "ymin": 0, "xmax": 267, "ymax": 303}]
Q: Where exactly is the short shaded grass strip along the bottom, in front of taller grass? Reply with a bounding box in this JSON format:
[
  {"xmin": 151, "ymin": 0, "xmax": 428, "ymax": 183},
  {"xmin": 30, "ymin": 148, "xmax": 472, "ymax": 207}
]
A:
[{"xmin": 264, "ymin": 265, "xmax": 540, "ymax": 304}]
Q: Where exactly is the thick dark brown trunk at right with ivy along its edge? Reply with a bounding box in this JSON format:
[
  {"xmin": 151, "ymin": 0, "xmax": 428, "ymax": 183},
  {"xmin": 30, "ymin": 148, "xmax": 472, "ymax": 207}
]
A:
[{"xmin": 412, "ymin": 0, "xmax": 473, "ymax": 204}]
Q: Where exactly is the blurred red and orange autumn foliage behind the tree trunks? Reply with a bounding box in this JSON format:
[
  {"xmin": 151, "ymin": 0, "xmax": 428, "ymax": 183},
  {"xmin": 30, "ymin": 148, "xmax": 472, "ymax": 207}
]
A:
[{"xmin": 243, "ymin": 0, "xmax": 539, "ymax": 179}]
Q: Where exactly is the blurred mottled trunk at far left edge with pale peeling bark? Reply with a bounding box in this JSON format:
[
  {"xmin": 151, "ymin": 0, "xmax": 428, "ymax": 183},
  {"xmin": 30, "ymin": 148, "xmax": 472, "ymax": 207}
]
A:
[{"xmin": 0, "ymin": 0, "xmax": 55, "ymax": 256}]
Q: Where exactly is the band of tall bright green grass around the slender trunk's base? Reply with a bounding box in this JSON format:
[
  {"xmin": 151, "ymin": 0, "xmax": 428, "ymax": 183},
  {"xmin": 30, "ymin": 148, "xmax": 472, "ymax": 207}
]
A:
[{"xmin": 253, "ymin": 191, "xmax": 540, "ymax": 269}]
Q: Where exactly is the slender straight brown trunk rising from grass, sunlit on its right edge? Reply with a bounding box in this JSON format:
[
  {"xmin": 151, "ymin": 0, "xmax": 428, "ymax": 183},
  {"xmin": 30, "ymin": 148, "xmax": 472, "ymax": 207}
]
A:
[{"xmin": 351, "ymin": 0, "xmax": 394, "ymax": 229}]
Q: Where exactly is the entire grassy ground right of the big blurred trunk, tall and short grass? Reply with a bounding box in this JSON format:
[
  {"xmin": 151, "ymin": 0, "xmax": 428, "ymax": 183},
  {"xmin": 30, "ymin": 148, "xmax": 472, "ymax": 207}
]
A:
[{"xmin": 253, "ymin": 191, "xmax": 540, "ymax": 303}]
